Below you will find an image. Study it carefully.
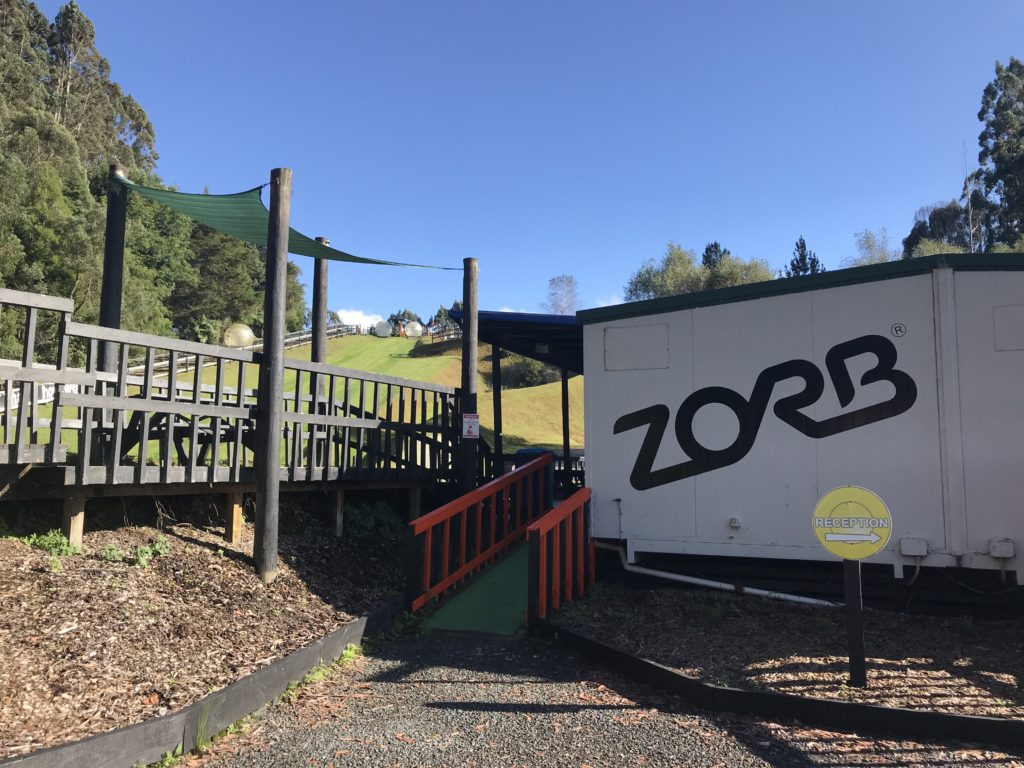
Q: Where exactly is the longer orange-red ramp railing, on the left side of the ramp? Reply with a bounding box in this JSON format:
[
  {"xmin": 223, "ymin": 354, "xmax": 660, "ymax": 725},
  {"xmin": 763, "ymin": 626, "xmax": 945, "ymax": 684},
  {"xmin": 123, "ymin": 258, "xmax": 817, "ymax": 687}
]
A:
[{"xmin": 406, "ymin": 454, "xmax": 552, "ymax": 610}]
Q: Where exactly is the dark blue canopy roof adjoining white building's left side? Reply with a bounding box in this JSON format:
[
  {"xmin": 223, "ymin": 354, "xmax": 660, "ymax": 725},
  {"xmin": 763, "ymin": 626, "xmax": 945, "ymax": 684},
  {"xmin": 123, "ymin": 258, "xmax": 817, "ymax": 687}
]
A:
[{"xmin": 449, "ymin": 309, "xmax": 583, "ymax": 374}]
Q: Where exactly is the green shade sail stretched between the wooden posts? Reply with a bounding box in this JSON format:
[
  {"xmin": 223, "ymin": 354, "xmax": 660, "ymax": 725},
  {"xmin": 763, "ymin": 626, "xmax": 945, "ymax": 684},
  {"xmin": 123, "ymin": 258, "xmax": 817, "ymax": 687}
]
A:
[{"xmin": 117, "ymin": 177, "xmax": 460, "ymax": 271}]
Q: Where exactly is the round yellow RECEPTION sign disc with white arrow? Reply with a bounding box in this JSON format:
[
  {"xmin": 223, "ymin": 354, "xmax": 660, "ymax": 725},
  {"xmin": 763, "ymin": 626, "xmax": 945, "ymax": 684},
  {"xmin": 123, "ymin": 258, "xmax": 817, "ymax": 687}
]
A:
[{"xmin": 811, "ymin": 485, "xmax": 893, "ymax": 560}]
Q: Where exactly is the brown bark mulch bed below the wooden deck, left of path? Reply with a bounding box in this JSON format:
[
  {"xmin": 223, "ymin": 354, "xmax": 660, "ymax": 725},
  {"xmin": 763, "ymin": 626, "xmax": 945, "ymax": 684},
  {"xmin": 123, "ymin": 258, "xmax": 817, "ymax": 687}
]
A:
[{"xmin": 0, "ymin": 505, "xmax": 401, "ymax": 759}]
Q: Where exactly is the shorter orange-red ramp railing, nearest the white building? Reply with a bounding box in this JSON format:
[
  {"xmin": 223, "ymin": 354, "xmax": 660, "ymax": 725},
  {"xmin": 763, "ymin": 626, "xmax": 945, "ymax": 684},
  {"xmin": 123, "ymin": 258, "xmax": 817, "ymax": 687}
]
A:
[{"xmin": 526, "ymin": 488, "xmax": 594, "ymax": 623}]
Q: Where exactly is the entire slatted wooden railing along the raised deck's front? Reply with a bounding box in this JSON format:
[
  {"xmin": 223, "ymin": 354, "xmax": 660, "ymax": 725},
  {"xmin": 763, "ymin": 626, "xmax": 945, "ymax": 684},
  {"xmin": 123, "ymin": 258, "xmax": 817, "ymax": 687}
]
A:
[{"xmin": 0, "ymin": 290, "xmax": 459, "ymax": 485}]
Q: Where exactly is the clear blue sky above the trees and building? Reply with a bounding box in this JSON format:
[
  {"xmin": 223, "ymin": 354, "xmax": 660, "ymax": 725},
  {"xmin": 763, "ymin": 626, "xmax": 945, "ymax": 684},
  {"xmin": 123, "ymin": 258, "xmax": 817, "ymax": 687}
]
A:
[{"xmin": 40, "ymin": 0, "xmax": 1024, "ymax": 325}]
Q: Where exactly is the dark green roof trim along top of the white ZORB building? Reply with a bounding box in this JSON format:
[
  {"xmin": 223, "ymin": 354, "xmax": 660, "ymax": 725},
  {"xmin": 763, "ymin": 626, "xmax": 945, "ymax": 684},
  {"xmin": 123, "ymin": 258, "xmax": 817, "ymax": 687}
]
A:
[{"xmin": 577, "ymin": 253, "xmax": 1024, "ymax": 326}]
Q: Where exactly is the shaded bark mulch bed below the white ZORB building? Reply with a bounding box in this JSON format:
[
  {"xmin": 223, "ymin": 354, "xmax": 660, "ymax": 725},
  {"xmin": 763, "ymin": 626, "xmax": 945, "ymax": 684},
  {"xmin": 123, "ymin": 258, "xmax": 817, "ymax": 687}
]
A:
[{"xmin": 555, "ymin": 582, "xmax": 1024, "ymax": 718}]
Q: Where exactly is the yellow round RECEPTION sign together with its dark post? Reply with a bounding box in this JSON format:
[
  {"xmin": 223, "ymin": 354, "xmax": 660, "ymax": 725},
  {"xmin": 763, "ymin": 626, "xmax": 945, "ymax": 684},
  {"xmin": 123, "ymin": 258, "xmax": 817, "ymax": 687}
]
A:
[{"xmin": 811, "ymin": 485, "xmax": 892, "ymax": 688}]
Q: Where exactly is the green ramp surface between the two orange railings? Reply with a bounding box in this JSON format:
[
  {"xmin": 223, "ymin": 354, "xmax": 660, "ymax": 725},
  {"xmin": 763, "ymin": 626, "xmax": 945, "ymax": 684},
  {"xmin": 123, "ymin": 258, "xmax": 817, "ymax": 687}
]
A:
[{"xmin": 423, "ymin": 544, "xmax": 529, "ymax": 635}]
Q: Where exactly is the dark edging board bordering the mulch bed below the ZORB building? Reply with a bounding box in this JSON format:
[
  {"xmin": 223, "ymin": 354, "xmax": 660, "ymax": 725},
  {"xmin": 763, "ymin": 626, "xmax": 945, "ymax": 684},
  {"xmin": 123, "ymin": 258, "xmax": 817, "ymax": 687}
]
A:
[{"xmin": 530, "ymin": 618, "xmax": 1024, "ymax": 750}]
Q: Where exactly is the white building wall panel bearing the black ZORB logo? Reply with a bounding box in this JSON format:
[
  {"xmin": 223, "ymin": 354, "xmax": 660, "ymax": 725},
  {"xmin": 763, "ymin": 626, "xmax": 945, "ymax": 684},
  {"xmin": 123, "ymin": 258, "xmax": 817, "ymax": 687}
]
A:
[{"xmin": 585, "ymin": 274, "xmax": 946, "ymax": 564}]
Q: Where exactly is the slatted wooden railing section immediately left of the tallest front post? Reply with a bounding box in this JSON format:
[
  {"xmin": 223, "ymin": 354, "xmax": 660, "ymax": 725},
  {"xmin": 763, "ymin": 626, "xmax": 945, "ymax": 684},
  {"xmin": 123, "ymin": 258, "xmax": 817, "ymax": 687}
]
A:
[{"xmin": 59, "ymin": 323, "xmax": 259, "ymax": 484}]
